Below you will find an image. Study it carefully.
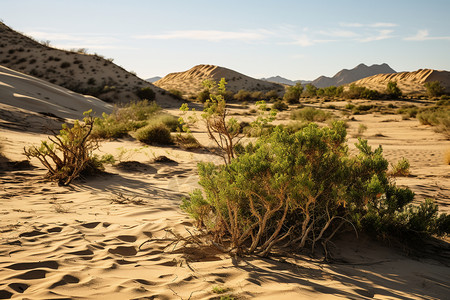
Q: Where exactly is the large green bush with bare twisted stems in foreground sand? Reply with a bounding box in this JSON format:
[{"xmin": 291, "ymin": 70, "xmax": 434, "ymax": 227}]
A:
[{"xmin": 181, "ymin": 122, "xmax": 450, "ymax": 255}]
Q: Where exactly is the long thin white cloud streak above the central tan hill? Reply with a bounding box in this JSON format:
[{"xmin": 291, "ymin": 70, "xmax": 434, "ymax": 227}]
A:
[{"xmin": 134, "ymin": 30, "xmax": 272, "ymax": 42}]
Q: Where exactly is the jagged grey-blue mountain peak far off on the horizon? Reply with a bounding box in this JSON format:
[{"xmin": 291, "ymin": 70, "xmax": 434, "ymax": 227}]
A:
[{"xmin": 311, "ymin": 64, "xmax": 396, "ymax": 88}]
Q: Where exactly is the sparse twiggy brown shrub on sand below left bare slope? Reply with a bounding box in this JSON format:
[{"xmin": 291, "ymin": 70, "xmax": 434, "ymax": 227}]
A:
[{"xmin": 24, "ymin": 111, "xmax": 107, "ymax": 185}]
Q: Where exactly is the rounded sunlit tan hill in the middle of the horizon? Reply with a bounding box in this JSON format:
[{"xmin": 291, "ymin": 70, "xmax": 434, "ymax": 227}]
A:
[{"xmin": 155, "ymin": 65, "xmax": 284, "ymax": 95}]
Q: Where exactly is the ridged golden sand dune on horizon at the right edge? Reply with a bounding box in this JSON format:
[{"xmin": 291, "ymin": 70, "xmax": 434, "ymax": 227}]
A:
[{"xmin": 354, "ymin": 69, "xmax": 450, "ymax": 94}]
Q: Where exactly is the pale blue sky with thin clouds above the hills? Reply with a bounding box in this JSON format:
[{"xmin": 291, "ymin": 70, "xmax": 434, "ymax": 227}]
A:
[{"xmin": 0, "ymin": 0, "xmax": 450, "ymax": 80}]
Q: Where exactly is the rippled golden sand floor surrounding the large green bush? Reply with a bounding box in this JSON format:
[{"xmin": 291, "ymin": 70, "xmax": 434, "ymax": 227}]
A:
[{"xmin": 0, "ymin": 99, "xmax": 450, "ymax": 299}]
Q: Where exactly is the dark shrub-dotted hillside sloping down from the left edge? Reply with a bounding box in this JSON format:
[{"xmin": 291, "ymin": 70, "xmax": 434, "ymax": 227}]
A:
[{"xmin": 0, "ymin": 22, "xmax": 170, "ymax": 102}]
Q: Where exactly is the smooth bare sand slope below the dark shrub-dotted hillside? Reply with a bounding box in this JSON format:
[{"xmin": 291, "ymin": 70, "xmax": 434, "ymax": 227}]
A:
[{"xmin": 0, "ymin": 66, "xmax": 112, "ymax": 130}]
